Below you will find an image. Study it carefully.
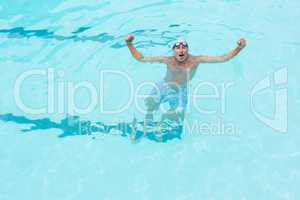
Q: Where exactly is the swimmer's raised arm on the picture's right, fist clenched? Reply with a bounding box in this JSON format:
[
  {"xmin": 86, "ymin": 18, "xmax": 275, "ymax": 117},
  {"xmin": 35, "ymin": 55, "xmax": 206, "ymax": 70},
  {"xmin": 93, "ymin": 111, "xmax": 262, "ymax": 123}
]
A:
[{"xmin": 196, "ymin": 38, "xmax": 246, "ymax": 63}]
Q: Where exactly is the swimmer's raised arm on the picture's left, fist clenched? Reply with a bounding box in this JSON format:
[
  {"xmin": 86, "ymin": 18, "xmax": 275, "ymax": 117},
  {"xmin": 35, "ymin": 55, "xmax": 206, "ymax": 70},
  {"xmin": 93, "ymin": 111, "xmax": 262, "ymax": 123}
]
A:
[{"xmin": 125, "ymin": 35, "xmax": 166, "ymax": 63}]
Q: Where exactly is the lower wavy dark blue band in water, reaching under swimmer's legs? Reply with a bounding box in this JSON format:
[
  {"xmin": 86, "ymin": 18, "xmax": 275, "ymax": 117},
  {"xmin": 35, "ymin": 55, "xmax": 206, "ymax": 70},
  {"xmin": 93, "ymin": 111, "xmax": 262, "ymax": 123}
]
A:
[{"xmin": 0, "ymin": 113, "xmax": 182, "ymax": 143}]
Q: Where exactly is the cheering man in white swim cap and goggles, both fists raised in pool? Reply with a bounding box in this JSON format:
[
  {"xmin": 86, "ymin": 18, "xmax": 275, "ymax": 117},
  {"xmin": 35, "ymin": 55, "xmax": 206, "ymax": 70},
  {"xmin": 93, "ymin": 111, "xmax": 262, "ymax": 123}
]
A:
[{"xmin": 125, "ymin": 35, "xmax": 246, "ymax": 125}]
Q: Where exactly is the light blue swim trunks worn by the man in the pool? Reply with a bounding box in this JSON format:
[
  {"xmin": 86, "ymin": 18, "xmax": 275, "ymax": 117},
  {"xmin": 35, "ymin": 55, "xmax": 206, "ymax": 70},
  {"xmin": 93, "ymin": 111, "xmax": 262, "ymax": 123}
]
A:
[{"xmin": 149, "ymin": 82, "xmax": 187, "ymax": 110}]
